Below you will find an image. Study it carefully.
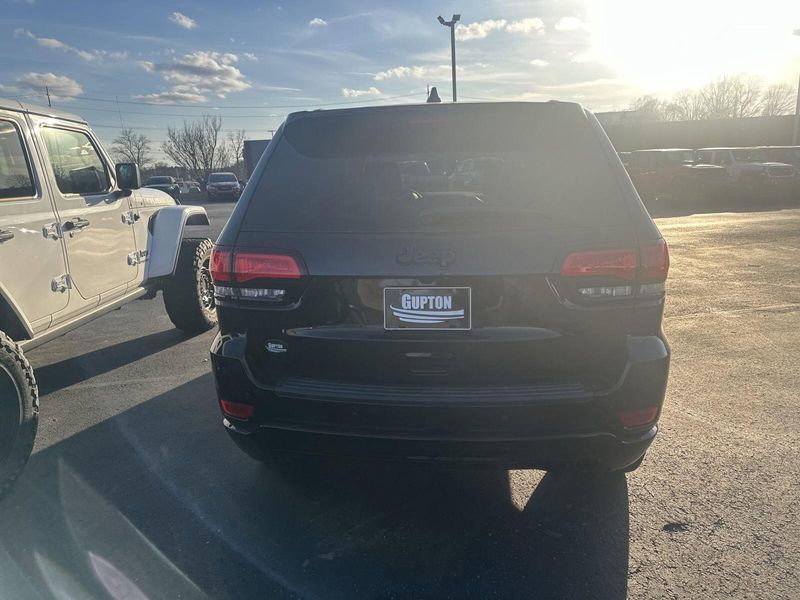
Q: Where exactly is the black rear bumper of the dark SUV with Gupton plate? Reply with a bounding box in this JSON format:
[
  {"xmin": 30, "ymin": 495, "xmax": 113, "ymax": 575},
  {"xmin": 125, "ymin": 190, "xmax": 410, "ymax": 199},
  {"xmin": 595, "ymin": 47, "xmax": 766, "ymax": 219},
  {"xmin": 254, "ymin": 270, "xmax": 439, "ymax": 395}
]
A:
[{"xmin": 211, "ymin": 335, "xmax": 669, "ymax": 470}]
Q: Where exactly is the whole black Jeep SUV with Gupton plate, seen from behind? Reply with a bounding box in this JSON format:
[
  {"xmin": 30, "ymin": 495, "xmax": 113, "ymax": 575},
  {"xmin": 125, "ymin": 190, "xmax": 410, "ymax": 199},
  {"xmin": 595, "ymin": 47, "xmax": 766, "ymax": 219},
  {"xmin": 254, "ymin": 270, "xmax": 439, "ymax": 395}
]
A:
[{"xmin": 211, "ymin": 102, "xmax": 669, "ymax": 471}]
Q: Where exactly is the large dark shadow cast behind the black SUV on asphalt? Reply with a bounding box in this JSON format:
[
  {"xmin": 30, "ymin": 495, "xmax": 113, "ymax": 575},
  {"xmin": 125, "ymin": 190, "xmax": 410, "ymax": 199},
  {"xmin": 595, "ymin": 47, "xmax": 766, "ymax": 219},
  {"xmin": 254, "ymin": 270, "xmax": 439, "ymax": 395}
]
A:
[{"xmin": 0, "ymin": 375, "xmax": 628, "ymax": 598}]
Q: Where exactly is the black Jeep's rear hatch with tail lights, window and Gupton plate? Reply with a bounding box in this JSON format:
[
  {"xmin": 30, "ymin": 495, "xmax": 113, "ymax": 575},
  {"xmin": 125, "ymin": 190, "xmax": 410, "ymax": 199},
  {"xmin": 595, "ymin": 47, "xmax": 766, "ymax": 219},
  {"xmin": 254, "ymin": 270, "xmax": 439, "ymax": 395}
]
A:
[{"xmin": 213, "ymin": 103, "xmax": 667, "ymax": 394}]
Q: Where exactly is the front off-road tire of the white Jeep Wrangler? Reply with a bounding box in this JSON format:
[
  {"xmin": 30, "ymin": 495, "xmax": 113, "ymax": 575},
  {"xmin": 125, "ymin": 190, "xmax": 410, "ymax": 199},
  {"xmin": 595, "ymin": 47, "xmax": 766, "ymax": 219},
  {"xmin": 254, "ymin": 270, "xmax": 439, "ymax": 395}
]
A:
[{"xmin": 163, "ymin": 238, "xmax": 217, "ymax": 334}]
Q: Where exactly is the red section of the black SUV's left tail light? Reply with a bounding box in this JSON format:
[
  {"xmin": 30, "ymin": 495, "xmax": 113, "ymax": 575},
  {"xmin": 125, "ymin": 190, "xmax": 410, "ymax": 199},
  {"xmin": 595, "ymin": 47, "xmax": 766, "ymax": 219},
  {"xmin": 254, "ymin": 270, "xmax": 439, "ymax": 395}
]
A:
[{"xmin": 210, "ymin": 246, "xmax": 302, "ymax": 284}]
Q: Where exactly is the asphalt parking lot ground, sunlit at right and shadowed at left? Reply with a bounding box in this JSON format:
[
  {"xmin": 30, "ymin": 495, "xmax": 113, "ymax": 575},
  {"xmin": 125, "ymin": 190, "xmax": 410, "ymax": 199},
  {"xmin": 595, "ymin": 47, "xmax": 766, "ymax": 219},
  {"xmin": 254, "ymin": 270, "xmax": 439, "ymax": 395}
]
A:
[{"xmin": 0, "ymin": 204, "xmax": 800, "ymax": 599}]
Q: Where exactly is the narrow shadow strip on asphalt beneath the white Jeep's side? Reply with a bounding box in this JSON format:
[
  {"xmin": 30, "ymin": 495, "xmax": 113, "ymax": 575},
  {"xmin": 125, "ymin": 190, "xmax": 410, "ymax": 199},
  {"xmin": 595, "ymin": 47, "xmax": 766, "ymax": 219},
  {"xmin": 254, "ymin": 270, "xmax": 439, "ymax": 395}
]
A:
[{"xmin": 32, "ymin": 329, "xmax": 191, "ymax": 396}]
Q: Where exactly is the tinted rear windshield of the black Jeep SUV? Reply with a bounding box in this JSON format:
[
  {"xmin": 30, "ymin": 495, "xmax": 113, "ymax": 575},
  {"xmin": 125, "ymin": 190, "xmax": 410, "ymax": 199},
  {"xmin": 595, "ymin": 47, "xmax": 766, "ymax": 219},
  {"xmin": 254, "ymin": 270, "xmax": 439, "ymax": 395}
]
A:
[{"xmin": 243, "ymin": 105, "xmax": 626, "ymax": 232}]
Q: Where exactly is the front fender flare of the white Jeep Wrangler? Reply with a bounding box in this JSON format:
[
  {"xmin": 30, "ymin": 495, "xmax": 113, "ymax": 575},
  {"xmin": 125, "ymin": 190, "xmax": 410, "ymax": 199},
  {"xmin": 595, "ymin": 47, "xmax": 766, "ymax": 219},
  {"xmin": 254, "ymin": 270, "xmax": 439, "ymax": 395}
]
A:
[{"xmin": 144, "ymin": 204, "xmax": 210, "ymax": 282}]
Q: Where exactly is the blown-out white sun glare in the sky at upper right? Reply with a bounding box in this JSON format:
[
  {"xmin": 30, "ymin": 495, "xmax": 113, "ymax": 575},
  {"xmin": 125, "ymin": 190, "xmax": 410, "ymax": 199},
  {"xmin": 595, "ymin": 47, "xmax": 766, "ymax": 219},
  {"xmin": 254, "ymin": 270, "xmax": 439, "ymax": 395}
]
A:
[{"xmin": 587, "ymin": 0, "xmax": 800, "ymax": 93}]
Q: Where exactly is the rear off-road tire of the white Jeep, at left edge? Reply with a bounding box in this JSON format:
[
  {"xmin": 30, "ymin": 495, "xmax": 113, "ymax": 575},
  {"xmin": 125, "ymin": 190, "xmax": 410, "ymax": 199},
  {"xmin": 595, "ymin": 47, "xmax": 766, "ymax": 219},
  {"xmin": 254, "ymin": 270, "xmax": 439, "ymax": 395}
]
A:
[{"xmin": 0, "ymin": 331, "xmax": 39, "ymax": 498}]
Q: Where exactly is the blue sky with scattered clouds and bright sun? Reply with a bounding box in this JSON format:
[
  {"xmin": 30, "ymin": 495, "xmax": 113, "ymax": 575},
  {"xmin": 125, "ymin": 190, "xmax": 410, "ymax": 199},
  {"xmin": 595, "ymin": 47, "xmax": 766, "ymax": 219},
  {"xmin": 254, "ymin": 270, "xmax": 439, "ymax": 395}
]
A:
[{"xmin": 0, "ymin": 0, "xmax": 800, "ymax": 157}]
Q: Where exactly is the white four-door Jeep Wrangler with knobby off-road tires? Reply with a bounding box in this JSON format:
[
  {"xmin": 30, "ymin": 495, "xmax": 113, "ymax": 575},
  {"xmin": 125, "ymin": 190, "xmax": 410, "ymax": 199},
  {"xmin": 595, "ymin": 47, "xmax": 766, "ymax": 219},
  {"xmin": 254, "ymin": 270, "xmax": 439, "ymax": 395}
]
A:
[{"xmin": 0, "ymin": 99, "xmax": 217, "ymax": 496}]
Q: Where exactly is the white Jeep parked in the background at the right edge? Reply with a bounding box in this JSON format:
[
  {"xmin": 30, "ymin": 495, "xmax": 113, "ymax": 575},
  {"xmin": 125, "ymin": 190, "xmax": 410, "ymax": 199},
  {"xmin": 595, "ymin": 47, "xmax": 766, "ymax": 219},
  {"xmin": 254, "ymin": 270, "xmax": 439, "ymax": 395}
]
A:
[{"xmin": 697, "ymin": 148, "xmax": 795, "ymax": 197}]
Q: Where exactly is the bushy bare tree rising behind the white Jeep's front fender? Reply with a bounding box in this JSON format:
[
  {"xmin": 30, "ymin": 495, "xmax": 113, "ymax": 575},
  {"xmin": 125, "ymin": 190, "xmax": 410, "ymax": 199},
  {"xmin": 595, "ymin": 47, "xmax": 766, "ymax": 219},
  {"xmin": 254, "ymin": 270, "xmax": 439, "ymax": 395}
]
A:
[{"xmin": 161, "ymin": 115, "xmax": 230, "ymax": 182}]
